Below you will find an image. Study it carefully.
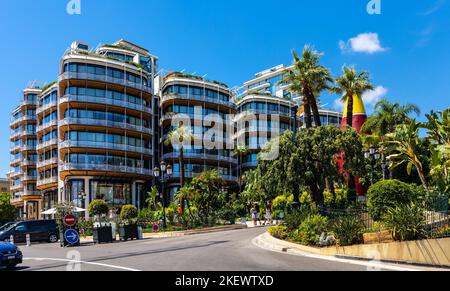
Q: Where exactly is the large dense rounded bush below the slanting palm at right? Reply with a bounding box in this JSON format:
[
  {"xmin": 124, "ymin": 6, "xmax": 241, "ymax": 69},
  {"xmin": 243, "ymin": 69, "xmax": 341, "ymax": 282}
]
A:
[{"xmin": 367, "ymin": 180, "xmax": 418, "ymax": 221}]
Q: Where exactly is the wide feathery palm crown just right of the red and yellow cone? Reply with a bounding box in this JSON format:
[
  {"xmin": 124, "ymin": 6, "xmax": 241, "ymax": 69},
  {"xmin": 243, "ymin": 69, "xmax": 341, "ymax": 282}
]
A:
[{"xmin": 362, "ymin": 99, "xmax": 420, "ymax": 139}]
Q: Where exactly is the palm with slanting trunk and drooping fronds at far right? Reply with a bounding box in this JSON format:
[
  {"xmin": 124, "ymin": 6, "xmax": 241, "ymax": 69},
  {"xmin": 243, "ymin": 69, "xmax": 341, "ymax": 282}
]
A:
[{"xmin": 385, "ymin": 120, "xmax": 428, "ymax": 192}]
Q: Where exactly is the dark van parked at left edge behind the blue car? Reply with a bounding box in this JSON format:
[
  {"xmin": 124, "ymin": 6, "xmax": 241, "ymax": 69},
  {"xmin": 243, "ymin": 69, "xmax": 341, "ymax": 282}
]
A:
[{"xmin": 0, "ymin": 220, "xmax": 59, "ymax": 243}]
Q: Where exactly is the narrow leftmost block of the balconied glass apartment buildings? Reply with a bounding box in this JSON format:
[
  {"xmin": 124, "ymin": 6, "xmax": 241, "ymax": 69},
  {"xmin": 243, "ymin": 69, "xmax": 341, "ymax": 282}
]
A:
[{"xmin": 9, "ymin": 82, "xmax": 42, "ymax": 219}]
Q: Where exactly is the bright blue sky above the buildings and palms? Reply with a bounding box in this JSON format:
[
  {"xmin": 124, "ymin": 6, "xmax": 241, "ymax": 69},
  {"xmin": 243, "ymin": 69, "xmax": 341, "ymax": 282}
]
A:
[{"xmin": 0, "ymin": 0, "xmax": 450, "ymax": 177}]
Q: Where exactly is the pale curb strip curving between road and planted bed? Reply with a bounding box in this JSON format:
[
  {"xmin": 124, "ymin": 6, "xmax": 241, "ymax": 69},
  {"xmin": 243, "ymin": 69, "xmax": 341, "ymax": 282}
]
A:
[{"xmin": 252, "ymin": 237, "xmax": 421, "ymax": 272}]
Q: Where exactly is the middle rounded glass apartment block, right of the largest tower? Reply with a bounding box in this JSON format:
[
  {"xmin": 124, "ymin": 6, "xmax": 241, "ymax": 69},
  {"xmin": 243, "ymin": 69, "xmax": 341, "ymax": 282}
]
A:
[{"xmin": 159, "ymin": 72, "xmax": 238, "ymax": 201}]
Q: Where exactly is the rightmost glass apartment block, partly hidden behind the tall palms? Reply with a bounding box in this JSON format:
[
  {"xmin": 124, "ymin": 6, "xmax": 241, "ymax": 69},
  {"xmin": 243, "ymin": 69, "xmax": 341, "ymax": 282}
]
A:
[{"xmin": 235, "ymin": 65, "xmax": 342, "ymax": 170}]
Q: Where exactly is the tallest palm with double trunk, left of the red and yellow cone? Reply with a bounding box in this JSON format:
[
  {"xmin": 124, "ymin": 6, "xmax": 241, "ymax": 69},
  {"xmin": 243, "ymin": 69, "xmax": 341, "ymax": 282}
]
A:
[{"xmin": 279, "ymin": 45, "xmax": 333, "ymax": 128}]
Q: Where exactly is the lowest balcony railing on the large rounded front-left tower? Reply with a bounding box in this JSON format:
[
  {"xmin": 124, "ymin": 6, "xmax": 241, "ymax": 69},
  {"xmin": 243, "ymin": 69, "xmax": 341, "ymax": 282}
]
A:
[{"xmin": 60, "ymin": 163, "xmax": 153, "ymax": 176}]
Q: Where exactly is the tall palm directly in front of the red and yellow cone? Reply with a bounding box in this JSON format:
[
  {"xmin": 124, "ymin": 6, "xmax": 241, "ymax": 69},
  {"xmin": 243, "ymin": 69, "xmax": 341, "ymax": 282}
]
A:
[{"xmin": 330, "ymin": 66, "xmax": 374, "ymax": 128}]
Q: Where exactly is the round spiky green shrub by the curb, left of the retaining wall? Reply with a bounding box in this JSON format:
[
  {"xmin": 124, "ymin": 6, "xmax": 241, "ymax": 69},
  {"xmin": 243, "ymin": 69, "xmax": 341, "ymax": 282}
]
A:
[{"xmin": 332, "ymin": 216, "xmax": 364, "ymax": 246}]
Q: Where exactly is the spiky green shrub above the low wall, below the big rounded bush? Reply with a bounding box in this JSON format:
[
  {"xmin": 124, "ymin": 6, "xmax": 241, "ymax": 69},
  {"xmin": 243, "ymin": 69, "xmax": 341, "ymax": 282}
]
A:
[{"xmin": 383, "ymin": 203, "xmax": 425, "ymax": 241}]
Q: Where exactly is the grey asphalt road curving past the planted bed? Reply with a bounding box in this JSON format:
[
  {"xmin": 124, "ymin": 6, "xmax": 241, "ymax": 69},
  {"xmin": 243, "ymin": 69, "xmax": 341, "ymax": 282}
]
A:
[{"xmin": 2, "ymin": 228, "xmax": 432, "ymax": 271}]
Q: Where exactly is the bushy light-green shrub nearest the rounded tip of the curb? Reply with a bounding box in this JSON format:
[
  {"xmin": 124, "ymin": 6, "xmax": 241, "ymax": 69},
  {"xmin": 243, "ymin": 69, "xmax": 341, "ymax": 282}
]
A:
[{"xmin": 290, "ymin": 214, "xmax": 328, "ymax": 246}]
